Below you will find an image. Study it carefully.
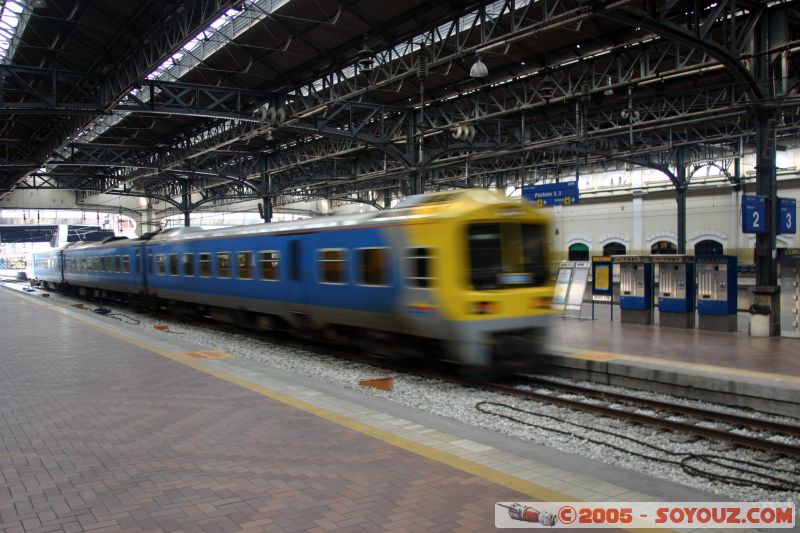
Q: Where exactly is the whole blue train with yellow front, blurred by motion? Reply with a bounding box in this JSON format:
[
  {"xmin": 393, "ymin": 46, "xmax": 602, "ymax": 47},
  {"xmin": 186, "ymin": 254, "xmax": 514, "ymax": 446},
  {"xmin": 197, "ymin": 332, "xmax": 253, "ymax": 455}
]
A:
[{"xmin": 32, "ymin": 189, "xmax": 553, "ymax": 372}]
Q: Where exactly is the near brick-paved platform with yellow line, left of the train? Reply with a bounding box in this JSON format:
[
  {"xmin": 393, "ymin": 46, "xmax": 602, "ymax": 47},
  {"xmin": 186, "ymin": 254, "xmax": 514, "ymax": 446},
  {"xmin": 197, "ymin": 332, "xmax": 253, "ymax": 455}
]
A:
[{"xmin": 0, "ymin": 288, "xmax": 744, "ymax": 533}]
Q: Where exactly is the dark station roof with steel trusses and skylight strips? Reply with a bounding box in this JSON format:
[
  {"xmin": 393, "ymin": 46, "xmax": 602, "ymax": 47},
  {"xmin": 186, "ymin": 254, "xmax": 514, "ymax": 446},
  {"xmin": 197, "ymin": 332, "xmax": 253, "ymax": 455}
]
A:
[{"xmin": 0, "ymin": 0, "xmax": 800, "ymax": 214}]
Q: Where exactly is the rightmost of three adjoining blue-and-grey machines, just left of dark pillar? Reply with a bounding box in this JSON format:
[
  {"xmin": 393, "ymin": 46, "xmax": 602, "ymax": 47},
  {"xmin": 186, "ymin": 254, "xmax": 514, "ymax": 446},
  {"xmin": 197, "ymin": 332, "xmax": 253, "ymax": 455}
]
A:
[{"xmin": 695, "ymin": 255, "xmax": 738, "ymax": 331}]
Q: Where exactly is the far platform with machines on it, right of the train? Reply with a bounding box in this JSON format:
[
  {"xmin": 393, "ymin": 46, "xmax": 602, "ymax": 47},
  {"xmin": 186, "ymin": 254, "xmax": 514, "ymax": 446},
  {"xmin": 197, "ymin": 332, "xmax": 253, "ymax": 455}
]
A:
[{"xmin": 543, "ymin": 305, "xmax": 800, "ymax": 416}]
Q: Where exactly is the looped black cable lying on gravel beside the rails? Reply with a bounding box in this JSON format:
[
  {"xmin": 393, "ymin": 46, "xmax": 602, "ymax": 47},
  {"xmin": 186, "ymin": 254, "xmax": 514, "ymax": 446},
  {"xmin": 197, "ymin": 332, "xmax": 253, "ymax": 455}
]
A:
[{"xmin": 475, "ymin": 400, "xmax": 800, "ymax": 492}]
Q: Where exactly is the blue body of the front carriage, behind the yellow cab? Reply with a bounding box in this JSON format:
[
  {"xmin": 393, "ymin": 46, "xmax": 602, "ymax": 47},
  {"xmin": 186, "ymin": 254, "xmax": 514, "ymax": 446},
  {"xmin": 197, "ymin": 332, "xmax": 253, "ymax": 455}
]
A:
[{"xmin": 142, "ymin": 215, "xmax": 398, "ymax": 333}]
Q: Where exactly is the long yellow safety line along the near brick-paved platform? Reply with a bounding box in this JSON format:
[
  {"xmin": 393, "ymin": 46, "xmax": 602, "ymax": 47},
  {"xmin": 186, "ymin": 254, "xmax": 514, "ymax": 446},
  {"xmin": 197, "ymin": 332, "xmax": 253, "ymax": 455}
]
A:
[{"xmin": 3, "ymin": 288, "xmax": 581, "ymax": 501}]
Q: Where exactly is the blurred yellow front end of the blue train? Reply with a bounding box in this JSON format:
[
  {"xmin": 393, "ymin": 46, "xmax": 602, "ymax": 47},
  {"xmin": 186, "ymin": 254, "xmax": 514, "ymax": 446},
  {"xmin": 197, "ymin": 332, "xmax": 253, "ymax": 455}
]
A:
[{"xmin": 385, "ymin": 189, "xmax": 553, "ymax": 369}]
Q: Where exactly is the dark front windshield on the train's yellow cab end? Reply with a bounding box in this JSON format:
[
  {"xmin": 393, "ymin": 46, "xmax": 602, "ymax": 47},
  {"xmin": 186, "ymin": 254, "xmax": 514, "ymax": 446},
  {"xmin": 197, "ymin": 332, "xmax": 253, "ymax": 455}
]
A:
[{"xmin": 467, "ymin": 223, "xmax": 547, "ymax": 290}]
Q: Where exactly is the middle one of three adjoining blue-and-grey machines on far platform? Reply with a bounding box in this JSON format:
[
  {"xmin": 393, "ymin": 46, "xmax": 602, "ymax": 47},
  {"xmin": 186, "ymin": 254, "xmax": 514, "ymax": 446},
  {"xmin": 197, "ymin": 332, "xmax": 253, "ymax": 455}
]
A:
[{"xmin": 653, "ymin": 255, "xmax": 695, "ymax": 328}]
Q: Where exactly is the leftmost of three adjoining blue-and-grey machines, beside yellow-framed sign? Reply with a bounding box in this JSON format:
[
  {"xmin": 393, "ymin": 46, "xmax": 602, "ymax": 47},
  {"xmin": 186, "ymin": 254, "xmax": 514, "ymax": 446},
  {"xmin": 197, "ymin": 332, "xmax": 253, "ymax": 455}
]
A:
[{"xmin": 613, "ymin": 255, "xmax": 653, "ymax": 325}]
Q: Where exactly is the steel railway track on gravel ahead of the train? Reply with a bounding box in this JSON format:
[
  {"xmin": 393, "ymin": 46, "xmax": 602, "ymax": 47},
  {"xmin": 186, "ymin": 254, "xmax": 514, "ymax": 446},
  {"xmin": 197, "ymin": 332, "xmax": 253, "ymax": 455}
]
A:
[{"xmin": 479, "ymin": 376, "xmax": 800, "ymax": 458}]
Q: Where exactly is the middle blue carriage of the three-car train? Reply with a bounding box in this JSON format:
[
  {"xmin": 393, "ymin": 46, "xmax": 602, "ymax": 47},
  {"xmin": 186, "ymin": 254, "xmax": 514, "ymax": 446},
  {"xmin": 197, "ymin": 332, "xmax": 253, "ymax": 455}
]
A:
[{"xmin": 62, "ymin": 237, "xmax": 145, "ymax": 298}]
